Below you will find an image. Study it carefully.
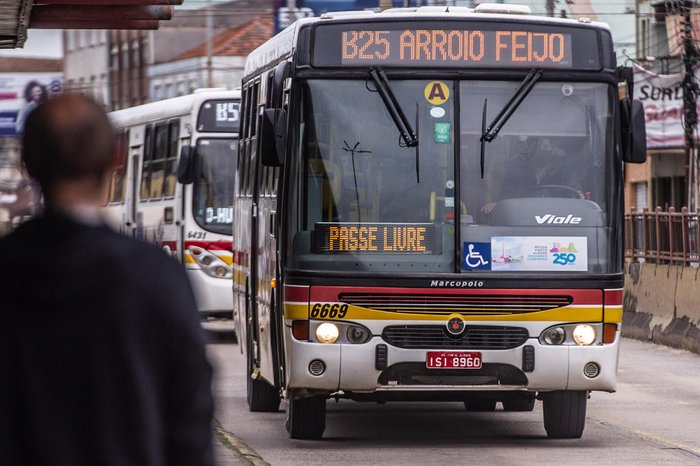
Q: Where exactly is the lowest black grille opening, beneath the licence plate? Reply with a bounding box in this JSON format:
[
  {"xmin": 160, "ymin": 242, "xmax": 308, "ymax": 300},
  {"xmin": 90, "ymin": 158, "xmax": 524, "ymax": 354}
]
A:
[{"xmin": 378, "ymin": 362, "xmax": 528, "ymax": 386}]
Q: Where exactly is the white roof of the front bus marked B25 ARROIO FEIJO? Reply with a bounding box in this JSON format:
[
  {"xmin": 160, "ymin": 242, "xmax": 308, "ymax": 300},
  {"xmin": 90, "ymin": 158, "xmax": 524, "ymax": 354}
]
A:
[{"xmin": 244, "ymin": 3, "xmax": 610, "ymax": 80}]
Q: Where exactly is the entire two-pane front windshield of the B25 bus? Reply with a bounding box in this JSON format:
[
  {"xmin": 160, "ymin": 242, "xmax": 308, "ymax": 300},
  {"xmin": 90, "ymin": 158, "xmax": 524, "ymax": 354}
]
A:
[{"xmin": 290, "ymin": 79, "xmax": 619, "ymax": 274}]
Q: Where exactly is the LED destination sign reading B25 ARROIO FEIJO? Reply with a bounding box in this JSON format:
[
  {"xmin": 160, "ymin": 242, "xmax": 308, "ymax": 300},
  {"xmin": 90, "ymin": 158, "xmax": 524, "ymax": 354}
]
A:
[{"xmin": 314, "ymin": 22, "xmax": 600, "ymax": 69}]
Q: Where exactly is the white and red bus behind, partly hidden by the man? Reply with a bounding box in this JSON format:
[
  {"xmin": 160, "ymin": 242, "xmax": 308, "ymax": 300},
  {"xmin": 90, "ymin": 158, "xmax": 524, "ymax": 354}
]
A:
[{"xmin": 105, "ymin": 89, "xmax": 240, "ymax": 318}]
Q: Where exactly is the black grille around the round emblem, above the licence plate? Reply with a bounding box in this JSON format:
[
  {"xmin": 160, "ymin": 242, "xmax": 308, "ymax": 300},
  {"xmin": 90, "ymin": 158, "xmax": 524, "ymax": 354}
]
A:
[{"xmin": 382, "ymin": 325, "xmax": 529, "ymax": 350}]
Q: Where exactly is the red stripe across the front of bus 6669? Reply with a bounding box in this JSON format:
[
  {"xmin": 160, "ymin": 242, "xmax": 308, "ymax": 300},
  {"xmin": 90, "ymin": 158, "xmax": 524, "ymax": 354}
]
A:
[{"xmin": 310, "ymin": 286, "xmax": 603, "ymax": 305}]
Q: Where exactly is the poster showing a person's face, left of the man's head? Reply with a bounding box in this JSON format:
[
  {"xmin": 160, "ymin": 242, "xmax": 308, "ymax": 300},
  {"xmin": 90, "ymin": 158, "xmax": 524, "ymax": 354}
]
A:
[{"xmin": 0, "ymin": 72, "xmax": 63, "ymax": 137}]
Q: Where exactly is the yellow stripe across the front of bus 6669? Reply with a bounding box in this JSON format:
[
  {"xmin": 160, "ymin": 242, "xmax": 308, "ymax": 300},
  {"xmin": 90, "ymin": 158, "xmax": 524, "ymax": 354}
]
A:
[{"xmin": 284, "ymin": 303, "xmax": 622, "ymax": 323}]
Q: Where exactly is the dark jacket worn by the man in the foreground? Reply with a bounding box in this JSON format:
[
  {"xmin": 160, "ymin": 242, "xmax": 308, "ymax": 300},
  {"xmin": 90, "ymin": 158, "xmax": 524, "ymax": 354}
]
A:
[{"xmin": 0, "ymin": 213, "xmax": 213, "ymax": 465}]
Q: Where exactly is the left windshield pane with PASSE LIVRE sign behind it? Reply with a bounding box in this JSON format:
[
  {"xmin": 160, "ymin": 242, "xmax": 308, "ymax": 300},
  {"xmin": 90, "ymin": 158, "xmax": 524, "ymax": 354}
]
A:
[{"xmin": 292, "ymin": 79, "xmax": 454, "ymax": 273}]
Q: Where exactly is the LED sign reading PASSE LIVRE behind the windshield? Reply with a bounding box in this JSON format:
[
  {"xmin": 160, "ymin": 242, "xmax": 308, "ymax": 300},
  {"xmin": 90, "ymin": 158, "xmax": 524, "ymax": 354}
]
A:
[{"xmin": 314, "ymin": 223, "xmax": 435, "ymax": 254}]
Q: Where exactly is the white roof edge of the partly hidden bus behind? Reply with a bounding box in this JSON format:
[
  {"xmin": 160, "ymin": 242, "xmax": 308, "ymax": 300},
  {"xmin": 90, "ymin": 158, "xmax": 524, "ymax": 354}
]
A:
[{"xmin": 109, "ymin": 88, "xmax": 241, "ymax": 128}]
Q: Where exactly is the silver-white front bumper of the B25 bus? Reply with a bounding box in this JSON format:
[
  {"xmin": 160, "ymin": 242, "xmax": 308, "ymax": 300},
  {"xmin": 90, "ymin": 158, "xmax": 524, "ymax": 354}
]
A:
[{"xmin": 287, "ymin": 330, "xmax": 620, "ymax": 393}]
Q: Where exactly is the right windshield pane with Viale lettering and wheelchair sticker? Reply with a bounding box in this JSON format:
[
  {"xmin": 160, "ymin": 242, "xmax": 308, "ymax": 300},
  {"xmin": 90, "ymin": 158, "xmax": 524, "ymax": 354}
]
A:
[{"xmin": 460, "ymin": 81, "xmax": 619, "ymax": 272}]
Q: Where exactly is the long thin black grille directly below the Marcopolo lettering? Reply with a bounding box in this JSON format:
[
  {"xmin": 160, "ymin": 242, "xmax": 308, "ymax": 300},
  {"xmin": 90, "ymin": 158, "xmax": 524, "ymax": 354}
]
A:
[{"xmin": 338, "ymin": 293, "xmax": 573, "ymax": 316}]
